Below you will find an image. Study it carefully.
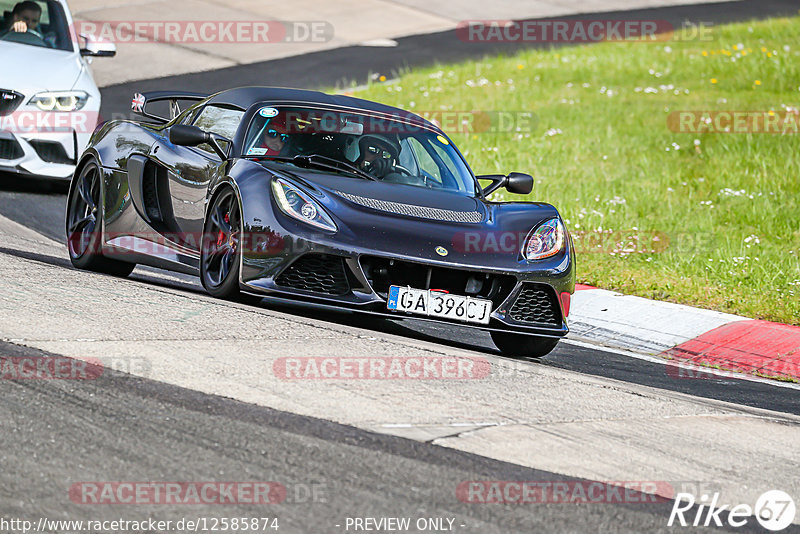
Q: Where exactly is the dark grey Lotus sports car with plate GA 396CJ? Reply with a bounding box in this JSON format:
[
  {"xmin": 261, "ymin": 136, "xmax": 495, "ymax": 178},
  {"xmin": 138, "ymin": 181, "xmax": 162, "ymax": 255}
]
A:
[{"xmin": 66, "ymin": 87, "xmax": 575, "ymax": 357}]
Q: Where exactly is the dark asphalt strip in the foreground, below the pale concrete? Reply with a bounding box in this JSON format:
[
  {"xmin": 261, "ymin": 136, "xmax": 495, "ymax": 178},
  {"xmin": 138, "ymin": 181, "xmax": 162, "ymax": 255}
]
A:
[{"xmin": 0, "ymin": 343, "xmax": 780, "ymax": 533}]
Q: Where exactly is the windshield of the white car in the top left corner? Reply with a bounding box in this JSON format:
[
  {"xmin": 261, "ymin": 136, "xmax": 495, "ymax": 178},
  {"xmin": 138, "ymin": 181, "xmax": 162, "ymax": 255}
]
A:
[{"xmin": 0, "ymin": 0, "xmax": 72, "ymax": 52}]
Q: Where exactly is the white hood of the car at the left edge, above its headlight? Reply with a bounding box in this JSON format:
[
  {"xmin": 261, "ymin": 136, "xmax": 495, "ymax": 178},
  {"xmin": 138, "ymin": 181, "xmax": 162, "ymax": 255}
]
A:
[{"xmin": 0, "ymin": 41, "xmax": 83, "ymax": 99}]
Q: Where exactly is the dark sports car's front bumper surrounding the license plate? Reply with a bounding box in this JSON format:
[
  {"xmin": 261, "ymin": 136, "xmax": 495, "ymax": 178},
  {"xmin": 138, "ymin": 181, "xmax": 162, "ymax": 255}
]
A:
[{"xmin": 241, "ymin": 233, "xmax": 575, "ymax": 337}]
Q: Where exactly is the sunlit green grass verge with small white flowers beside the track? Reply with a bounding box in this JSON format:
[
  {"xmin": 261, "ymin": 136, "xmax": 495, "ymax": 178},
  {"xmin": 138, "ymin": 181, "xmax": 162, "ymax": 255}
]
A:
[{"xmin": 348, "ymin": 18, "xmax": 800, "ymax": 325}]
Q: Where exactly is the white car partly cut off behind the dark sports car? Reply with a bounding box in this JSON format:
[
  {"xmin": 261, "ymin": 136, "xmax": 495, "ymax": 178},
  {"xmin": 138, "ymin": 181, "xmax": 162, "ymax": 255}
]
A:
[{"xmin": 0, "ymin": 0, "xmax": 116, "ymax": 179}]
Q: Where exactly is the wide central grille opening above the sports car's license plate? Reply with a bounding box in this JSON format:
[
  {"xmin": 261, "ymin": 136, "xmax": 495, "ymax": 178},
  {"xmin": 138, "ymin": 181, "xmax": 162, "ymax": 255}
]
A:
[{"xmin": 361, "ymin": 256, "xmax": 516, "ymax": 307}]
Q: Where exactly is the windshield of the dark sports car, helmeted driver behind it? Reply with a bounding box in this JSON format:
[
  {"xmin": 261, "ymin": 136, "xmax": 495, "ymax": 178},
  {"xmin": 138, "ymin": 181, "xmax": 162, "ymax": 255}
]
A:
[{"xmin": 243, "ymin": 106, "xmax": 476, "ymax": 196}]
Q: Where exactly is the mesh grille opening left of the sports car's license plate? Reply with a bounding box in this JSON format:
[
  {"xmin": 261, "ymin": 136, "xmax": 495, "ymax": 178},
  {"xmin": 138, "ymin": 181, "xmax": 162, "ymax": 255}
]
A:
[{"xmin": 275, "ymin": 254, "xmax": 350, "ymax": 295}]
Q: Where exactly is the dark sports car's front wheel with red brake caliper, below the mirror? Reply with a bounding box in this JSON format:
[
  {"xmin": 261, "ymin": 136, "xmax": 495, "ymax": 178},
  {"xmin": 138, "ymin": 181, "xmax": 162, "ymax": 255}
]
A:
[{"xmin": 200, "ymin": 186, "xmax": 261, "ymax": 304}]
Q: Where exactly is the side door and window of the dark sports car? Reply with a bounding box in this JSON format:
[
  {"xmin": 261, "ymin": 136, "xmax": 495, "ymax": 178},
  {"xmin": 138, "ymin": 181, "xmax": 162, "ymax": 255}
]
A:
[{"xmin": 150, "ymin": 104, "xmax": 244, "ymax": 250}]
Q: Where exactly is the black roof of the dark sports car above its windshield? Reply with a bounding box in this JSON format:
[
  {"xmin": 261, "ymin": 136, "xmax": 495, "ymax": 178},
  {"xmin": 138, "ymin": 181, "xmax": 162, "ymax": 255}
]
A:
[{"xmin": 203, "ymin": 86, "xmax": 439, "ymax": 130}]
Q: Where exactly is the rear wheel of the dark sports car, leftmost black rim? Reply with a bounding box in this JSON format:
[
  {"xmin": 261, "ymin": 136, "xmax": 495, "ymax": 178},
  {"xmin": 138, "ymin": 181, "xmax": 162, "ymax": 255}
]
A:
[{"xmin": 66, "ymin": 160, "xmax": 136, "ymax": 277}]
